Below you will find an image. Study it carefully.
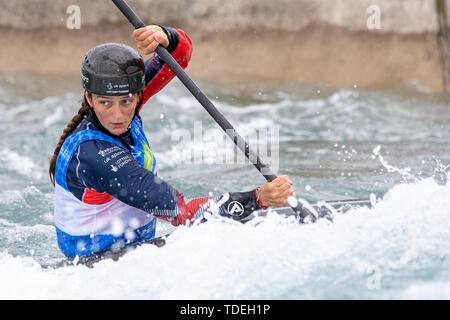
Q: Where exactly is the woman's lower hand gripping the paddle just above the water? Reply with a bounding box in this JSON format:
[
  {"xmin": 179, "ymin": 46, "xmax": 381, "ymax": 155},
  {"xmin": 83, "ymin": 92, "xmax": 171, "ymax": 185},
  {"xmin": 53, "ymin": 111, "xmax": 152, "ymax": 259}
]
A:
[{"xmin": 259, "ymin": 175, "xmax": 295, "ymax": 207}]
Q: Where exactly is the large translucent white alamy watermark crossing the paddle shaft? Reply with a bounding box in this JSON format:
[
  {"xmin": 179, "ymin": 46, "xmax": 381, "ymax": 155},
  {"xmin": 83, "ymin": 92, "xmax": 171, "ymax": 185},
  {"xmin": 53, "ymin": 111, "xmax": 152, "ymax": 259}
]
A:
[{"xmin": 171, "ymin": 121, "xmax": 280, "ymax": 174}]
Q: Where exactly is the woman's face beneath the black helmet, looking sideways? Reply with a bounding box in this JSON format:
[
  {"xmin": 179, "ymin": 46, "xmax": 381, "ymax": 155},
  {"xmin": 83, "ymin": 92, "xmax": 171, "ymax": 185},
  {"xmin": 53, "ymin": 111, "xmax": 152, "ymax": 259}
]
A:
[{"xmin": 85, "ymin": 92, "xmax": 139, "ymax": 136}]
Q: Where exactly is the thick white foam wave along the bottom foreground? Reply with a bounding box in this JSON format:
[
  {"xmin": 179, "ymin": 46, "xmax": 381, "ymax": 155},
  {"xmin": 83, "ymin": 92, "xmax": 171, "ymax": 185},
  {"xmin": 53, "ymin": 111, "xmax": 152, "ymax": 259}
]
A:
[{"xmin": 0, "ymin": 174, "xmax": 450, "ymax": 299}]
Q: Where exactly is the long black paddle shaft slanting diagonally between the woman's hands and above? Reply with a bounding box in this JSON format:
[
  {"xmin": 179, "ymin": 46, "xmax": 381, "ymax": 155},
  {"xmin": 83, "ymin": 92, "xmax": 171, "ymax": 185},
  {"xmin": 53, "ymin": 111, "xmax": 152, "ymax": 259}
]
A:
[{"xmin": 112, "ymin": 0, "xmax": 277, "ymax": 181}]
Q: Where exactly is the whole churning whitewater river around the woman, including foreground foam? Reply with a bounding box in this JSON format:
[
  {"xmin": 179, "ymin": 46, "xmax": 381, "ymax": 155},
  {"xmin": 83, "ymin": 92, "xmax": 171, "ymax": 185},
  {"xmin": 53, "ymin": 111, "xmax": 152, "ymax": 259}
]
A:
[{"xmin": 0, "ymin": 75, "xmax": 450, "ymax": 299}]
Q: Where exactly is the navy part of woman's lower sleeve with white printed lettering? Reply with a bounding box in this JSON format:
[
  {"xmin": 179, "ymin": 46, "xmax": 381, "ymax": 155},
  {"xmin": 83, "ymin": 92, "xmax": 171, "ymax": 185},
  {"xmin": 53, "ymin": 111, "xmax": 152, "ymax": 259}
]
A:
[{"xmin": 67, "ymin": 140, "xmax": 176, "ymax": 213}]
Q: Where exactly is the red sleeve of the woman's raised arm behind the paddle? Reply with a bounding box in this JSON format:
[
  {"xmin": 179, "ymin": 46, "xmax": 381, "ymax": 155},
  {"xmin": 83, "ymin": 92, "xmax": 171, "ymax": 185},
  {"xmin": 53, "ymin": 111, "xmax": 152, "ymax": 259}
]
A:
[{"xmin": 141, "ymin": 29, "xmax": 192, "ymax": 108}]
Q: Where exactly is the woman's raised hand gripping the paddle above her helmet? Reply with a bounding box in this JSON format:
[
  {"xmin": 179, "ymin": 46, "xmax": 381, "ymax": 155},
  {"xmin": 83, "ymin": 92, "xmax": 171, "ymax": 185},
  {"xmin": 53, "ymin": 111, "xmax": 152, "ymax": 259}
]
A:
[{"xmin": 133, "ymin": 25, "xmax": 169, "ymax": 55}]
